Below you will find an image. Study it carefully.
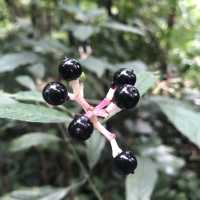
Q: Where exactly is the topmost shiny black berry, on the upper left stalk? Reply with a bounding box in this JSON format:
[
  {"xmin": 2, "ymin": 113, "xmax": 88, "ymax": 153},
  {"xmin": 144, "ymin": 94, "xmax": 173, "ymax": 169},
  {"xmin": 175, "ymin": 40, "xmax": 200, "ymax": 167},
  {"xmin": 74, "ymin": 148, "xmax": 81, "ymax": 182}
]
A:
[{"xmin": 58, "ymin": 58, "xmax": 82, "ymax": 81}]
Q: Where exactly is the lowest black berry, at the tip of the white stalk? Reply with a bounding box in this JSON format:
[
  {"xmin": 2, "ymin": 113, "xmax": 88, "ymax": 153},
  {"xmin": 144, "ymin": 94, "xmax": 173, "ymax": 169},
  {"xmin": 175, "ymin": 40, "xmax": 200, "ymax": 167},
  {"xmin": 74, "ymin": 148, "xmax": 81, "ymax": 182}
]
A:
[{"xmin": 113, "ymin": 151, "xmax": 137, "ymax": 175}]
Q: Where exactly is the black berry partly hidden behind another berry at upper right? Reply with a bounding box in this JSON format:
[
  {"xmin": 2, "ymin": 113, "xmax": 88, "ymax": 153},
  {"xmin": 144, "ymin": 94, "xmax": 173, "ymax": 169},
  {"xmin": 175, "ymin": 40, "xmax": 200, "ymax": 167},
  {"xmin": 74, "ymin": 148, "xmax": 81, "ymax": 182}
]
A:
[{"xmin": 113, "ymin": 68, "xmax": 136, "ymax": 86}]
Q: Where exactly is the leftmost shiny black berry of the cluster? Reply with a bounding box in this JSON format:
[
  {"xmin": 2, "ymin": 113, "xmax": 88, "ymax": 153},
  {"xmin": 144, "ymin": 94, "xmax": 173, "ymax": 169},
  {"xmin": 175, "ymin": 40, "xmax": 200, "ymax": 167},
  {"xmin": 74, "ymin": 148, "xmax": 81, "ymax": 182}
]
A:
[{"xmin": 42, "ymin": 81, "xmax": 69, "ymax": 106}]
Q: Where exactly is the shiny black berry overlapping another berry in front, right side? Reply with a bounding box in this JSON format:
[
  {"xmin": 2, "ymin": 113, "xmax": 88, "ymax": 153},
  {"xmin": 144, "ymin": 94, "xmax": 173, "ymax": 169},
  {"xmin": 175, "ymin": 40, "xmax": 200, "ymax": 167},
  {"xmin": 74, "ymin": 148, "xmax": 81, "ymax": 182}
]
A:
[{"xmin": 113, "ymin": 84, "xmax": 140, "ymax": 109}]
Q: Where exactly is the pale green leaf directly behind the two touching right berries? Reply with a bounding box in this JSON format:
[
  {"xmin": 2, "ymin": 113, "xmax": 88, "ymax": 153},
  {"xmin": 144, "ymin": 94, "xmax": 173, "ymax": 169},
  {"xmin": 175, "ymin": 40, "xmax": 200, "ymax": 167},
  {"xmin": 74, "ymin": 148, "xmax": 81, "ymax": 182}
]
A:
[{"xmin": 136, "ymin": 71, "xmax": 157, "ymax": 96}]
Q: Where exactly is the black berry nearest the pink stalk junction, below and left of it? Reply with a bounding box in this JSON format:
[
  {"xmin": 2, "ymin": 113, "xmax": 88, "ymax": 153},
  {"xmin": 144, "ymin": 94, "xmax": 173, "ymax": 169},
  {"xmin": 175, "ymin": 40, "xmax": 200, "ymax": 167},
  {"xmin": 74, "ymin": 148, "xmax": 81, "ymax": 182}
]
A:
[{"xmin": 68, "ymin": 115, "xmax": 94, "ymax": 141}]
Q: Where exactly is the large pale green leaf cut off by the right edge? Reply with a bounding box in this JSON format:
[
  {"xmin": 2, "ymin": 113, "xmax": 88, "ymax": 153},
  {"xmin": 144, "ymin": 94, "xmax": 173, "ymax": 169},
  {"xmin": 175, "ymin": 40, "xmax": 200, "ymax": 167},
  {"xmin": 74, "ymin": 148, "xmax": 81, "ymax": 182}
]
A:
[{"xmin": 152, "ymin": 97, "xmax": 200, "ymax": 147}]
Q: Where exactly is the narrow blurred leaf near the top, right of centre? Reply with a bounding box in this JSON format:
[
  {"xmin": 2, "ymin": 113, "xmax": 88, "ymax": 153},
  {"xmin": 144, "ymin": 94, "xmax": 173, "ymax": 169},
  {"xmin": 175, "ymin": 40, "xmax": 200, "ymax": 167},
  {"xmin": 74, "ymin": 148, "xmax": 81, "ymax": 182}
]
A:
[{"xmin": 103, "ymin": 21, "xmax": 144, "ymax": 36}]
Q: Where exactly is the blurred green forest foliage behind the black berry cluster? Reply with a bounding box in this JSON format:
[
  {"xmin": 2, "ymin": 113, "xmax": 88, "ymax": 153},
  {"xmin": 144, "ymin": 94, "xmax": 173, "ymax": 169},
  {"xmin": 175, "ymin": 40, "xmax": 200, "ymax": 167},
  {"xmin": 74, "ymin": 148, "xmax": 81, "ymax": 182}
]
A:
[{"xmin": 0, "ymin": 0, "xmax": 200, "ymax": 200}]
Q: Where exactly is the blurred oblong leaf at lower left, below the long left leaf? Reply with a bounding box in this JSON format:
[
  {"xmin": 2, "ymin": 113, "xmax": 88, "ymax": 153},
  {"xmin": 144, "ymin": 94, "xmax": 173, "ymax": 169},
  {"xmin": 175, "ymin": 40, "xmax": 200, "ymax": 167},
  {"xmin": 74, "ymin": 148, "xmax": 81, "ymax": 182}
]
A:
[{"xmin": 8, "ymin": 132, "xmax": 60, "ymax": 152}]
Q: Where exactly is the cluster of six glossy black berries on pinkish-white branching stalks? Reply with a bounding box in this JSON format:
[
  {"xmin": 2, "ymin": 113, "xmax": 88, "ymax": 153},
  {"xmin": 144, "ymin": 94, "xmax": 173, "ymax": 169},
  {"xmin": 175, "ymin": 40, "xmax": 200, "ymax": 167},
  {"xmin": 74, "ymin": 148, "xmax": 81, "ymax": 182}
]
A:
[{"xmin": 43, "ymin": 58, "xmax": 140, "ymax": 175}]
